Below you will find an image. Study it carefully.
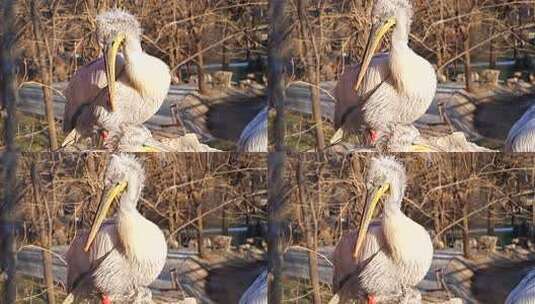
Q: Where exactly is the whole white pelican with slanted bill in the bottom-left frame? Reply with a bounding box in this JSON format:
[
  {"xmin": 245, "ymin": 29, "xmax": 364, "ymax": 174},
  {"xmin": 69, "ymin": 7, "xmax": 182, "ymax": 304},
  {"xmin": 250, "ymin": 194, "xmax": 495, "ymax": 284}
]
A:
[{"xmin": 64, "ymin": 154, "xmax": 167, "ymax": 304}]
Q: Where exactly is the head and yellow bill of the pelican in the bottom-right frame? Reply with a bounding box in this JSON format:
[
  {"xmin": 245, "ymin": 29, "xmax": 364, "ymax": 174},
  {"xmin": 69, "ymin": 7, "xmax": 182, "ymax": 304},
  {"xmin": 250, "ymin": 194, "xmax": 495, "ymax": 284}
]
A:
[{"xmin": 353, "ymin": 156, "xmax": 407, "ymax": 258}]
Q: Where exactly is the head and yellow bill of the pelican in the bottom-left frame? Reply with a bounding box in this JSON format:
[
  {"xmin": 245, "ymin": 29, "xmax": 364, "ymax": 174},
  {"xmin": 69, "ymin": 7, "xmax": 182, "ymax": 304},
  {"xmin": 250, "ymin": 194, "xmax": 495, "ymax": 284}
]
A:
[{"xmin": 84, "ymin": 154, "xmax": 145, "ymax": 252}]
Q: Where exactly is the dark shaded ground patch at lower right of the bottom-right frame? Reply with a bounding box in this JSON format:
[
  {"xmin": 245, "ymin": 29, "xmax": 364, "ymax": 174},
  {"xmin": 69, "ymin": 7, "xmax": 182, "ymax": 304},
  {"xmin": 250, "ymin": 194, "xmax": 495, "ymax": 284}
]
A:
[{"xmin": 472, "ymin": 261, "xmax": 535, "ymax": 304}]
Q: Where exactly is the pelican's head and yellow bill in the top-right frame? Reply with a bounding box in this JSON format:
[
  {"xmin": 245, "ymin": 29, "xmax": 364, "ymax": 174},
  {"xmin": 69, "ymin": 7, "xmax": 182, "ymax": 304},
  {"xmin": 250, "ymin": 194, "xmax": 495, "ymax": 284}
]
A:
[{"xmin": 353, "ymin": 0, "xmax": 413, "ymax": 91}]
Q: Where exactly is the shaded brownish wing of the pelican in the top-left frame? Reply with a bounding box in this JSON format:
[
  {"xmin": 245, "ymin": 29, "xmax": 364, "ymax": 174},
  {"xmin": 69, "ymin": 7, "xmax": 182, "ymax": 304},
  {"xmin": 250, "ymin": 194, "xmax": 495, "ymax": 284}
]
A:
[{"xmin": 63, "ymin": 54, "xmax": 125, "ymax": 132}]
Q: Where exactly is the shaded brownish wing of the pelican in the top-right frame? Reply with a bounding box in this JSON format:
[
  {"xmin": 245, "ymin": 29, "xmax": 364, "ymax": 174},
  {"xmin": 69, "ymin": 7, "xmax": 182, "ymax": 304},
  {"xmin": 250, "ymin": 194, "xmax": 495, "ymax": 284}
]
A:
[{"xmin": 334, "ymin": 53, "xmax": 390, "ymax": 129}]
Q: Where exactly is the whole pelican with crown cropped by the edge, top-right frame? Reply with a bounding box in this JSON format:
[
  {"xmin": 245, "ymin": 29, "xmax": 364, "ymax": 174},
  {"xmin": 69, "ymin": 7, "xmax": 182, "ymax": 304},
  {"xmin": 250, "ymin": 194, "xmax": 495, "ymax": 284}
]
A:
[{"xmin": 331, "ymin": 0, "xmax": 437, "ymax": 148}]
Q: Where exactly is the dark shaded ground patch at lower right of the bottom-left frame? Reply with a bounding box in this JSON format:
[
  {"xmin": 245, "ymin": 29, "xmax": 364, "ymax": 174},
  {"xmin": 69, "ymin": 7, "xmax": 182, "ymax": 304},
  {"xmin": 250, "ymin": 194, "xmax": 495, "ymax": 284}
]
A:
[{"xmin": 206, "ymin": 260, "xmax": 266, "ymax": 303}]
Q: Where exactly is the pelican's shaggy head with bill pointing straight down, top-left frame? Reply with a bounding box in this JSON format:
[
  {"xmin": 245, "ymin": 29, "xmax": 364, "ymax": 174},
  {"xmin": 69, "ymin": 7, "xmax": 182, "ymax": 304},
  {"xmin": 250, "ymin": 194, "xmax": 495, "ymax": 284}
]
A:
[{"xmin": 97, "ymin": 9, "xmax": 141, "ymax": 111}]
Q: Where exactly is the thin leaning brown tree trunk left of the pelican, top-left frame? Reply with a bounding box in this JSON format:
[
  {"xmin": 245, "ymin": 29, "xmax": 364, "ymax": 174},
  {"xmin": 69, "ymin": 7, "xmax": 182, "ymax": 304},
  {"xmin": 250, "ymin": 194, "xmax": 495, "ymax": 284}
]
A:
[{"xmin": 30, "ymin": 0, "xmax": 58, "ymax": 151}]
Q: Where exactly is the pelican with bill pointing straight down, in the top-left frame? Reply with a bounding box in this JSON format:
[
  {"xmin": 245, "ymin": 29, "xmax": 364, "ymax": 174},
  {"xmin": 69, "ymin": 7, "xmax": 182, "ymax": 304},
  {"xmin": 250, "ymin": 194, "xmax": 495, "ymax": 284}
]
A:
[{"xmin": 63, "ymin": 9, "xmax": 171, "ymax": 146}]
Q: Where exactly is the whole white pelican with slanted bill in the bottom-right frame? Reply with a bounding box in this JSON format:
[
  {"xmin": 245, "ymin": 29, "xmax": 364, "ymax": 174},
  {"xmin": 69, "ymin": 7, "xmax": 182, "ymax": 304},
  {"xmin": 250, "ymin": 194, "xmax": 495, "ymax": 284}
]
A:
[{"xmin": 329, "ymin": 157, "xmax": 433, "ymax": 304}]
